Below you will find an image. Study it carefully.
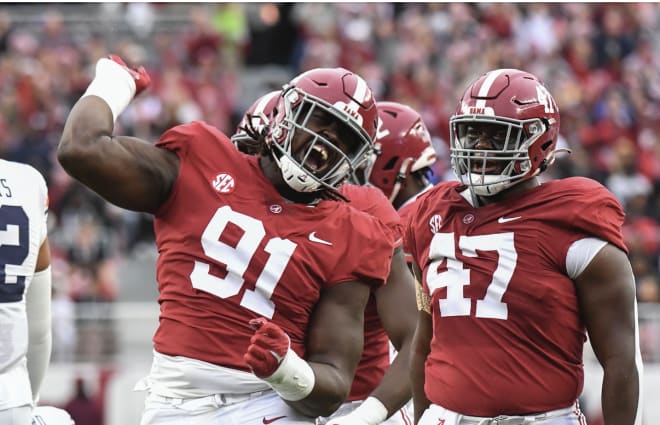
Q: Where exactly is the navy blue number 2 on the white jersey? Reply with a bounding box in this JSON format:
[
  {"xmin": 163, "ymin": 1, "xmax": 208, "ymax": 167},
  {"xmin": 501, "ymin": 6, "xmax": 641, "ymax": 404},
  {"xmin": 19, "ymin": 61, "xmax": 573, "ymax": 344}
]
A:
[{"xmin": 0, "ymin": 205, "xmax": 30, "ymax": 303}]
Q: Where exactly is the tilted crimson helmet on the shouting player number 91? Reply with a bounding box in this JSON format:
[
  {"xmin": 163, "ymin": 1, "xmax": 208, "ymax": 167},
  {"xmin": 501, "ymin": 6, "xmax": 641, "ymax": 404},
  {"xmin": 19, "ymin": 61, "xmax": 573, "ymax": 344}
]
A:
[{"xmin": 269, "ymin": 68, "xmax": 377, "ymax": 192}]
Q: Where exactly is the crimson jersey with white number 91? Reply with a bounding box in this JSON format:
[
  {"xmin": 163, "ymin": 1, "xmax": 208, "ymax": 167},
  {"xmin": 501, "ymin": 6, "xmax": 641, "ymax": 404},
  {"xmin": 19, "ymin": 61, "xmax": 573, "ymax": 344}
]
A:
[{"xmin": 154, "ymin": 122, "xmax": 394, "ymax": 371}]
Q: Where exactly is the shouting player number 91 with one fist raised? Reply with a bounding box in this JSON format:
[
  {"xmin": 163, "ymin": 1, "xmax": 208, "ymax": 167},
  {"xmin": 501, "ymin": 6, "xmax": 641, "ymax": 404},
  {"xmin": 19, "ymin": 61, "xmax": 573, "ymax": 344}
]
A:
[{"xmin": 58, "ymin": 56, "xmax": 395, "ymax": 425}]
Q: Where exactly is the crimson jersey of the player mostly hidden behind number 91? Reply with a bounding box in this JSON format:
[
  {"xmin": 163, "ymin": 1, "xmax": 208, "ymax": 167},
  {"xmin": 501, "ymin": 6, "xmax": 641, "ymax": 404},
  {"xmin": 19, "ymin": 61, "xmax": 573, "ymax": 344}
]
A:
[{"xmin": 340, "ymin": 184, "xmax": 402, "ymax": 401}]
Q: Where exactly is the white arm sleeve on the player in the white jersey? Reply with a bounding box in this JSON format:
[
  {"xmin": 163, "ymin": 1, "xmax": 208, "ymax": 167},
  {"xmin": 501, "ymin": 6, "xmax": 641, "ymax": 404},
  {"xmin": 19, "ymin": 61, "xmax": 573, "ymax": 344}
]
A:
[{"xmin": 25, "ymin": 266, "xmax": 52, "ymax": 402}]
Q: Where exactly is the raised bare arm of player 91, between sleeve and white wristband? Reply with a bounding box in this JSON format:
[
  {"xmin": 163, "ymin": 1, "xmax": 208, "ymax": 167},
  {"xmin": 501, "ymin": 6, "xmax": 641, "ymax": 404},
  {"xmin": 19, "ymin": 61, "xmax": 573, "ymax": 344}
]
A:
[{"xmin": 57, "ymin": 96, "xmax": 179, "ymax": 213}]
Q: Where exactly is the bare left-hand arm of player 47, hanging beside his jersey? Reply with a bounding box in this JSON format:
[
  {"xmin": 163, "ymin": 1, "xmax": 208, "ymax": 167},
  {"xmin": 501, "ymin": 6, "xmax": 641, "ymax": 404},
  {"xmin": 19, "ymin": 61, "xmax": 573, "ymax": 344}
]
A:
[{"xmin": 410, "ymin": 264, "xmax": 433, "ymax": 423}]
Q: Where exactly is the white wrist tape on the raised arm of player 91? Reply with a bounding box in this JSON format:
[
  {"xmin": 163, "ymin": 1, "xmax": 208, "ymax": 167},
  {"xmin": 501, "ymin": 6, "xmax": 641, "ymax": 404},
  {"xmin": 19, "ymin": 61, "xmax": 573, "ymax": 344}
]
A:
[{"xmin": 81, "ymin": 58, "xmax": 136, "ymax": 122}]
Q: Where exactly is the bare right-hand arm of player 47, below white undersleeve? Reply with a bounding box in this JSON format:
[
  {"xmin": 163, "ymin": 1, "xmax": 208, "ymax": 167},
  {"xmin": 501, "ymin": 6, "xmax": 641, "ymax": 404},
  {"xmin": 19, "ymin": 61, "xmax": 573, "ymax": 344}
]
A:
[{"xmin": 575, "ymin": 244, "xmax": 639, "ymax": 425}]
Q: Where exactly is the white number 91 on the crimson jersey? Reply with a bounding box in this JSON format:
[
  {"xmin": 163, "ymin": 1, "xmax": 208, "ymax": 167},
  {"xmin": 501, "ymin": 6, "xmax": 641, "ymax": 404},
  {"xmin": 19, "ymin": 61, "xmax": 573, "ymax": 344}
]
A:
[{"xmin": 190, "ymin": 205, "xmax": 297, "ymax": 319}]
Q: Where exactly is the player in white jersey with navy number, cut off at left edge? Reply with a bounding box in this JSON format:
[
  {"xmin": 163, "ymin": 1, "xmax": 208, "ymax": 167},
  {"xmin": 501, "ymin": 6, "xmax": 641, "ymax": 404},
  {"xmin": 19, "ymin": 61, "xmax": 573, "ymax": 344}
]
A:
[{"xmin": 0, "ymin": 159, "xmax": 52, "ymax": 425}]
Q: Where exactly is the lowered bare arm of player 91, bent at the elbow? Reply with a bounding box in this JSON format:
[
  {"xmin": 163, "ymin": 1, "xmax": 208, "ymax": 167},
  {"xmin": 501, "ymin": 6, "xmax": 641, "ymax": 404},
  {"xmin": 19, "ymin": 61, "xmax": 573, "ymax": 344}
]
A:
[{"xmin": 287, "ymin": 282, "xmax": 370, "ymax": 417}]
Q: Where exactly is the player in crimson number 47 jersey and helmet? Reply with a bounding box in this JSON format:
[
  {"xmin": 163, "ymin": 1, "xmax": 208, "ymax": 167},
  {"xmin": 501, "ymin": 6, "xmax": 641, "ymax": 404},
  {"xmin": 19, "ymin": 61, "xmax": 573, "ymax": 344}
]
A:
[{"xmin": 405, "ymin": 69, "xmax": 641, "ymax": 425}]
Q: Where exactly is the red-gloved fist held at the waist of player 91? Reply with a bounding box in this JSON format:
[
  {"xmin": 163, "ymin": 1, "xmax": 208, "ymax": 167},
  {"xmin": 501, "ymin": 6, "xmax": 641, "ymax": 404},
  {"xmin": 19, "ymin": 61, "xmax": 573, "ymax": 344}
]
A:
[{"xmin": 243, "ymin": 318, "xmax": 291, "ymax": 379}]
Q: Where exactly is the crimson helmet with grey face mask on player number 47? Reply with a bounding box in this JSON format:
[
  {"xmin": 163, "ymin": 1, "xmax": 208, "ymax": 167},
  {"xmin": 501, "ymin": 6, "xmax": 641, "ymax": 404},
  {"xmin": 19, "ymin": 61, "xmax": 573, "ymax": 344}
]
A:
[{"xmin": 449, "ymin": 69, "xmax": 559, "ymax": 196}]
